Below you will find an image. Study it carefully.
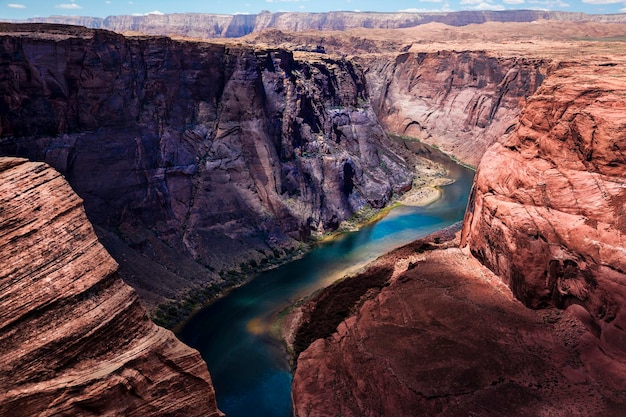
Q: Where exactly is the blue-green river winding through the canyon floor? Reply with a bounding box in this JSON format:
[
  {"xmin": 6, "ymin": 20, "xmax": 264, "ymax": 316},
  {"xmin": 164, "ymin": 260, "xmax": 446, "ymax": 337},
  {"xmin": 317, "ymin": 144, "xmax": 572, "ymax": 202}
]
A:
[{"xmin": 177, "ymin": 141, "xmax": 474, "ymax": 417}]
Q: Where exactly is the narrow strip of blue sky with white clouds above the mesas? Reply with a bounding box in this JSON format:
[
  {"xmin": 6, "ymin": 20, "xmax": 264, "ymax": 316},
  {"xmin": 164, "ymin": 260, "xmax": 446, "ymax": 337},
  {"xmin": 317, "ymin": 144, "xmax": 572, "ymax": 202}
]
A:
[{"xmin": 0, "ymin": 0, "xmax": 626, "ymax": 19}]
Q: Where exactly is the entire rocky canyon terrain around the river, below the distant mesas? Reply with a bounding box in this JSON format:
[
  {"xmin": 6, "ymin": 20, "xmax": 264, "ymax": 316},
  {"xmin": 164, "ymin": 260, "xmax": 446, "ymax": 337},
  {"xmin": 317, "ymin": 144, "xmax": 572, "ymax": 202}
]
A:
[{"xmin": 0, "ymin": 9, "xmax": 626, "ymax": 416}]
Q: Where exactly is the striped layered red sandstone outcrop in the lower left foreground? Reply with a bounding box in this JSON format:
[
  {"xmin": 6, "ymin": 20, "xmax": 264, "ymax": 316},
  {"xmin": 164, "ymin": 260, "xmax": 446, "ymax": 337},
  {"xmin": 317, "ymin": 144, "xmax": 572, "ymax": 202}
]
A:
[{"xmin": 0, "ymin": 158, "xmax": 221, "ymax": 416}]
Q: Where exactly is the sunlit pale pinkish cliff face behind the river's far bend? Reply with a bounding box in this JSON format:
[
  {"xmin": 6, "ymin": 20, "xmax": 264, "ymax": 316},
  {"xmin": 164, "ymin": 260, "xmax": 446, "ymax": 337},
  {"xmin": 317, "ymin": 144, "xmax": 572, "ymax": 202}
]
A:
[{"xmin": 362, "ymin": 51, "xmax": 550, "ymax": 166}]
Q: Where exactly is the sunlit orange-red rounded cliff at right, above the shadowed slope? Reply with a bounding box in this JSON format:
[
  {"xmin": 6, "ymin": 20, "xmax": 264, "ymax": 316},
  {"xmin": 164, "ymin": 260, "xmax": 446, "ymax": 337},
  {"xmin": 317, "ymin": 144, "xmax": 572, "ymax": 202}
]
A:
[{"xmin": 463, "ymin": 62, "xmax": 626, "ymax": 376}]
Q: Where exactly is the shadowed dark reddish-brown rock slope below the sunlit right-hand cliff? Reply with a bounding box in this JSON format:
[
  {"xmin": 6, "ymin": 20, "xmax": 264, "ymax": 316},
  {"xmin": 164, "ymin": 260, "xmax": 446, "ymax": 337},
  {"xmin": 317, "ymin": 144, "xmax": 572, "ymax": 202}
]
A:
[{"xmin": 292, "ymin": 232, "xmax": 626, "ymax": 417}]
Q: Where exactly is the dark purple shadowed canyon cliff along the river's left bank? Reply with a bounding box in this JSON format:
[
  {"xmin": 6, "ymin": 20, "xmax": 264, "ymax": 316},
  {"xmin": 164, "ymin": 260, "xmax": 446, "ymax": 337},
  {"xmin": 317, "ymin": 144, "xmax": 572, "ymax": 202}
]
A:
[{"xmin": 0, "ymin": 25, "xmax": 413, "ymax": 302}]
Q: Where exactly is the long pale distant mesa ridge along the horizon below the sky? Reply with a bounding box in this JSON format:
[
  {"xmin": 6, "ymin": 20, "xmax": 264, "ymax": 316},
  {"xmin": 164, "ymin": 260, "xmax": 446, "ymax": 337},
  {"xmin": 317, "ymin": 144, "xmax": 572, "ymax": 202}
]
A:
[{"xmin": 11, "ymin": 10, "xmax": 626, "ymax": 39}]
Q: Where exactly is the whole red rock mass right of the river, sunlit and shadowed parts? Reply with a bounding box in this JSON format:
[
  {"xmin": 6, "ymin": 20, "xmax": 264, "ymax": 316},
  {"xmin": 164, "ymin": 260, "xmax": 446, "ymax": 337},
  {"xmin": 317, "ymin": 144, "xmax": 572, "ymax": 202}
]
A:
[{"xmin": 293, "ymin": 56, "xmax": 626, "ymax": 417}]
